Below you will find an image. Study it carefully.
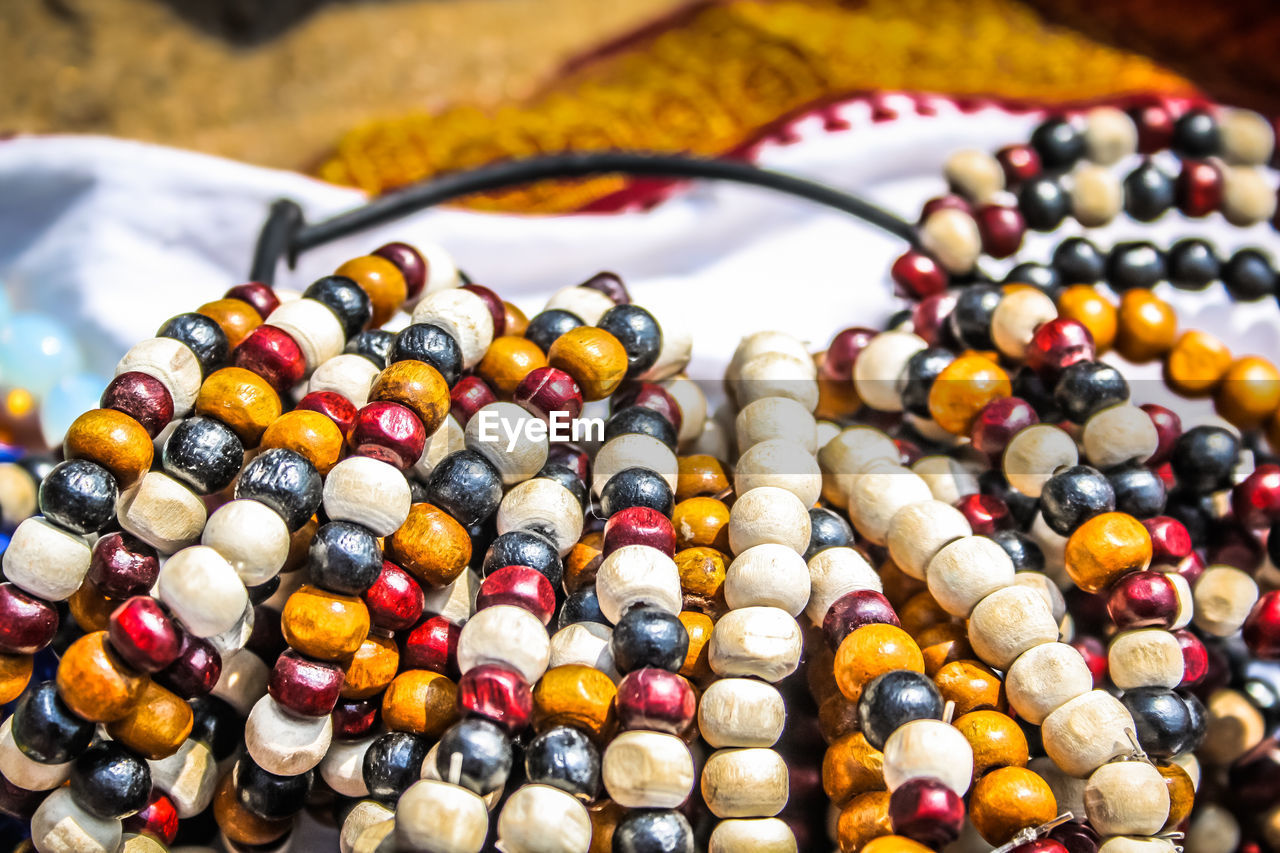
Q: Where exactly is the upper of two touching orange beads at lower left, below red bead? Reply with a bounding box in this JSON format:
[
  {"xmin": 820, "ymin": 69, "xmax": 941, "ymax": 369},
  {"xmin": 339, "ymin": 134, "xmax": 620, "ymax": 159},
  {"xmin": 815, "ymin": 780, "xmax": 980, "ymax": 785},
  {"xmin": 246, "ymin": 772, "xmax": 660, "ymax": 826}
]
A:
[{"xmin": 58, "ymin": 631, "xmax": 150, "ymax": 722}]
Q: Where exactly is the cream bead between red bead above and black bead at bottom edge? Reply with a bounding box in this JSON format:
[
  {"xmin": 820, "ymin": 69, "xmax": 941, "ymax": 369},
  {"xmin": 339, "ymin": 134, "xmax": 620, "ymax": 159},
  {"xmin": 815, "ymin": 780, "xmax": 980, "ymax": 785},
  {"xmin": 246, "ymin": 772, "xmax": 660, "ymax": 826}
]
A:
[{"xmin": 600, "ymin": 731, "xmax": 694, "ymax": 808}]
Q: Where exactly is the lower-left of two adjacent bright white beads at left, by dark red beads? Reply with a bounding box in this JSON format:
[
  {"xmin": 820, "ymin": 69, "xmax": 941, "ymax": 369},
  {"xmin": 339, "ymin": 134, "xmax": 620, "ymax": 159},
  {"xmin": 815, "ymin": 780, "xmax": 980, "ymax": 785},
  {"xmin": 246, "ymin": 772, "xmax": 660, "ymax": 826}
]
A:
[{"xmin": 156, "ymin": 546, "xmax": 248, "ymax": 637}]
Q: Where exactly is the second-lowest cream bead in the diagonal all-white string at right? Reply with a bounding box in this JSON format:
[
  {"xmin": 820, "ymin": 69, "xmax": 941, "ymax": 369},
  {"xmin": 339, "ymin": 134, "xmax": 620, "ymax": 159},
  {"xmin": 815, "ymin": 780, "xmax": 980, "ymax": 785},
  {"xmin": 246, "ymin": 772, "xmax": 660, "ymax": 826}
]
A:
[{"xmin": 1041, "ymin": 690, "xmax": 1133, "ymax": 776}]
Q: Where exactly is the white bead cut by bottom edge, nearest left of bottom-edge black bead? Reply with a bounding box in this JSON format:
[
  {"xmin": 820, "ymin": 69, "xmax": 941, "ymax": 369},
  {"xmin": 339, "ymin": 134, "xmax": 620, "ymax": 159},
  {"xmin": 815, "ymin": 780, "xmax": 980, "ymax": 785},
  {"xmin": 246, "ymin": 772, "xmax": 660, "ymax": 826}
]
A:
[{"xmin": 498, "ymin": 785, "xmax": 591, "ymax": 853}]
